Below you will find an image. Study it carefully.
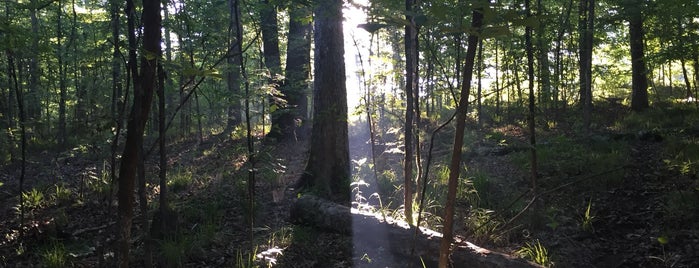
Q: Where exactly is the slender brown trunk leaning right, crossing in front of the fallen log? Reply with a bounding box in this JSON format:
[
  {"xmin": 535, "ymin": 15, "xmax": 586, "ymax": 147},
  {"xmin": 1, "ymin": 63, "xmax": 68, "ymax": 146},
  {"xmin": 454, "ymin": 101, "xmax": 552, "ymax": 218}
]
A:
[{"xmin": 439, "ymin": 6, "xmax": 483, "ymax": 268}]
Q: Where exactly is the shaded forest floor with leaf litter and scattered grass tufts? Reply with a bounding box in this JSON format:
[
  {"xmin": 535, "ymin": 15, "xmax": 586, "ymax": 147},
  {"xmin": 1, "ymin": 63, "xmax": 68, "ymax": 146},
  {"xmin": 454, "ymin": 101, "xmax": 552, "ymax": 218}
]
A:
[{"xmin": 0, "ymin": 104, "xmax": 699, "ymax": 267}]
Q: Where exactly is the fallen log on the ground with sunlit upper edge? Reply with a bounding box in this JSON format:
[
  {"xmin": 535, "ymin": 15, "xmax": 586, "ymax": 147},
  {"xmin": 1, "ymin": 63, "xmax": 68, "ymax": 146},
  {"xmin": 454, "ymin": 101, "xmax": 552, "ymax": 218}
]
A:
[{"xmin": 291, "ymin": 195, "xmax": 540, "ymax": 268}]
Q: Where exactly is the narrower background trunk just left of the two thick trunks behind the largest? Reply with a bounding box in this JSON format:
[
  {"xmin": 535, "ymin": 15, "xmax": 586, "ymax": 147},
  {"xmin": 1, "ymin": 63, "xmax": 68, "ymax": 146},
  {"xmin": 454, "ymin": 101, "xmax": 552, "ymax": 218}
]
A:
[{"xmin": 224, "ymin": 0, "xmax": 243, "ymax": 134}]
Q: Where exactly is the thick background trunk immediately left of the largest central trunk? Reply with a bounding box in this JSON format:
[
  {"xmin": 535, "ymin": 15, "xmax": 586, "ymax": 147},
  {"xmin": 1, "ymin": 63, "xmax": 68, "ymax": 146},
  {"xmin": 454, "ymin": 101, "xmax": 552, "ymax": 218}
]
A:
[{"xmin": 279, "ymin": 1, "xmax": 312, "ymax": 139}]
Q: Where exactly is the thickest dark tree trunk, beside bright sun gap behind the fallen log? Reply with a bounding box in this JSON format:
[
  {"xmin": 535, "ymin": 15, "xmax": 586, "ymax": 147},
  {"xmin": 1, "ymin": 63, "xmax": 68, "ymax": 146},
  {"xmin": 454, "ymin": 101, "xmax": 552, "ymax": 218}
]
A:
[{"xmin": 301, "ymin": 0, "xmax": 350, "ymax": 204}]
